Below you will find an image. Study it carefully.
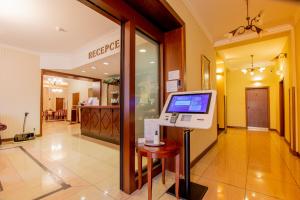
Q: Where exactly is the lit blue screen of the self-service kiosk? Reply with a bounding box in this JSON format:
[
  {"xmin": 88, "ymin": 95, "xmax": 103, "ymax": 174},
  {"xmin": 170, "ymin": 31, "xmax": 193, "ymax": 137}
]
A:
[{"xmin": 166, "ymin": 93, "xmax": 211, "ymax": 114}]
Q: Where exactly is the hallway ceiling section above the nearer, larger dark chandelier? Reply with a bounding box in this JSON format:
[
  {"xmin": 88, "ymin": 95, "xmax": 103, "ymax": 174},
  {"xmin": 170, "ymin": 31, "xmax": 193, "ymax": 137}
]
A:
[{"xmin": 184, "ymin": 0, "xmax": 300, "ymax": 42}]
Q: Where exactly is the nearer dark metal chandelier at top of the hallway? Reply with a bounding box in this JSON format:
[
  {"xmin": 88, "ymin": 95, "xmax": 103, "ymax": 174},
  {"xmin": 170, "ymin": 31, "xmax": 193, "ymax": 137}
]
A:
[{"xmin": 228, "ymin": 0, "xmax": 263, "ymax": 37}]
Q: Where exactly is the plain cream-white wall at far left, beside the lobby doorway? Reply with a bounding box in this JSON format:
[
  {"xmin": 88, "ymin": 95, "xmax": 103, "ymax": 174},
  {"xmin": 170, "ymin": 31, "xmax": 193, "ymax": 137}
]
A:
[{"xmin": 0, "ymin": 47, "xmax": 41, "ymax": 138}]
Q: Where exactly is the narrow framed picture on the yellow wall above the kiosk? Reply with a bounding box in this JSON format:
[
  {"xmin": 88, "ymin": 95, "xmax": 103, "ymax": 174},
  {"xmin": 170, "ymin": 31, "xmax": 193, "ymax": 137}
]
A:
[{"xmin": 201, "ymin": 55, "xmax": 211, "ymax": 90}]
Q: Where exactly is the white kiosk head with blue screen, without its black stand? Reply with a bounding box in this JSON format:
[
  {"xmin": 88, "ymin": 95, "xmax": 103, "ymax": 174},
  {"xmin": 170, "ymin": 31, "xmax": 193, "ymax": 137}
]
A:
[{"xmin": 160, "ymin": 90, "xmax": 216, "ymax": 129}]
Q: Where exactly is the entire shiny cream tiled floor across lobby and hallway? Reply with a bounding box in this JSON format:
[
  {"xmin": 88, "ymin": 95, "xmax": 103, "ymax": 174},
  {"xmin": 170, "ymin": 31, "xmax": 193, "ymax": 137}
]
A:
[{"xmin": 0, "ymin": 122, "xmax": 300, "ymax": 200}]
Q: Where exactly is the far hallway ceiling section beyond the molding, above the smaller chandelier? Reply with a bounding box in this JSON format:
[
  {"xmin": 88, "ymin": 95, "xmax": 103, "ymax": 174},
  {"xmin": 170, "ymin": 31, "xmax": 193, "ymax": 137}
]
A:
[{"xmin": 218, "ymin": 36, "xmax": 288, "ymax": 70}]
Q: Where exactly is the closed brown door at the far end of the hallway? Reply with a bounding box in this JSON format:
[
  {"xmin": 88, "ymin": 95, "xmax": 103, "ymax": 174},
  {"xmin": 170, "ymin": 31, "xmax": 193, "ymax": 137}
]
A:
[{"xmin": 246, "ymin": 88, "xmax": 269, "ymax": 128}]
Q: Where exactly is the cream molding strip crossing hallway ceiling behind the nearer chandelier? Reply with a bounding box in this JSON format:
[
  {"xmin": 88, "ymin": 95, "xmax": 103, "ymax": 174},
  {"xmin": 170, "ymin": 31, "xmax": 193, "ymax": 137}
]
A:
[{"xmin": 214, "ymin": 24, "xmax": 294, "ymax": 48}]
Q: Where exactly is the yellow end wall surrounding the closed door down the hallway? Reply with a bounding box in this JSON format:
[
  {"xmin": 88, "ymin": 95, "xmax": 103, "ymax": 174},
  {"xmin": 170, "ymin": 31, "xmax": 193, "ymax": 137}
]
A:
[{"xmin": 226, "ymin": 66, "xmax": 280, "ymax": 130}]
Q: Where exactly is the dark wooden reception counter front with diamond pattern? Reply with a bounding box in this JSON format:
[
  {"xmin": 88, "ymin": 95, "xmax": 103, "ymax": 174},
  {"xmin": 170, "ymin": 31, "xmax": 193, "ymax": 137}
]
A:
[{"xmin": 80, "ymin": 106, "xmax": 120, "ymax": 144}]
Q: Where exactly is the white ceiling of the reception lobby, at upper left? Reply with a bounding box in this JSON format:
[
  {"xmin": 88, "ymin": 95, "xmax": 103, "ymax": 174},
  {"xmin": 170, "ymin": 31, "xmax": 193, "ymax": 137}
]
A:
[{"xmin": 0, "ymin": 0, "xmax": 120, "ymax": 53}]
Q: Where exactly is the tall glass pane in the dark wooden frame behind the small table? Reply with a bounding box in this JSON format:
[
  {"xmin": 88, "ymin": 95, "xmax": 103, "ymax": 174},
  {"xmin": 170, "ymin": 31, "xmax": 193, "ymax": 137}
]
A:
[{"xmin": 135, "ymin": 31, "xmax": 160, "ymax": 140}]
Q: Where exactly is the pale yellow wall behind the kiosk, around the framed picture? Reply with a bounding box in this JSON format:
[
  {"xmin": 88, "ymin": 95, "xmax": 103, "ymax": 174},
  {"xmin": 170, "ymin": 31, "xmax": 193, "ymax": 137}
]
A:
[{"xmin": 168, "ymin": 0, "xmax": 217, "ymax": 160}]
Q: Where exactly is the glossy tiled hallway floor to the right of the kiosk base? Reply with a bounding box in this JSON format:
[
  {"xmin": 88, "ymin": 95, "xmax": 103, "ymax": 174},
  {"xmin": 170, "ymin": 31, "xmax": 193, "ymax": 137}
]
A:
[{"xmin": 185, "ymin": 129, "xmax": 300, "ymax": 200}]
